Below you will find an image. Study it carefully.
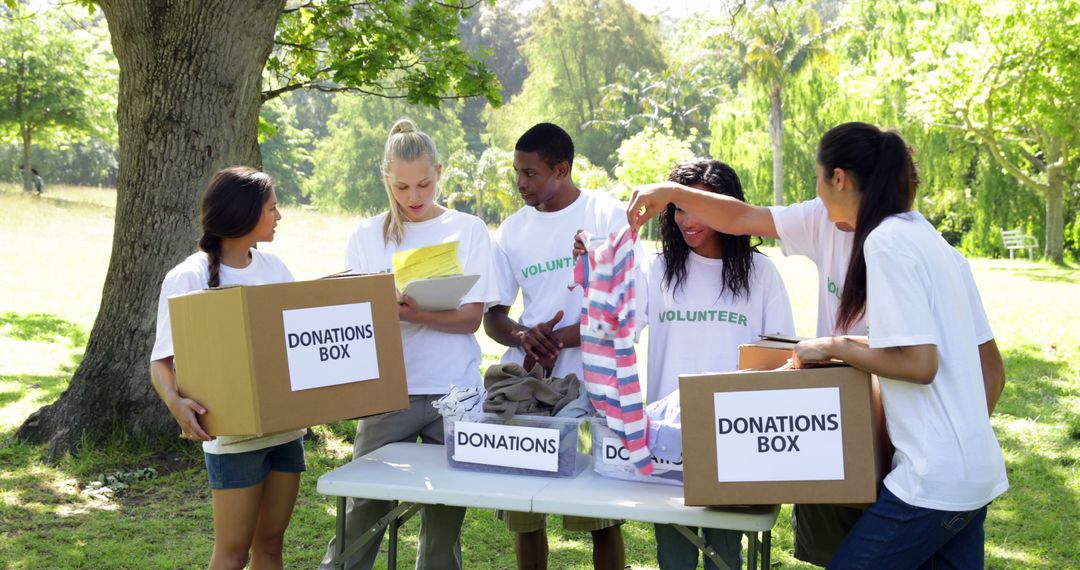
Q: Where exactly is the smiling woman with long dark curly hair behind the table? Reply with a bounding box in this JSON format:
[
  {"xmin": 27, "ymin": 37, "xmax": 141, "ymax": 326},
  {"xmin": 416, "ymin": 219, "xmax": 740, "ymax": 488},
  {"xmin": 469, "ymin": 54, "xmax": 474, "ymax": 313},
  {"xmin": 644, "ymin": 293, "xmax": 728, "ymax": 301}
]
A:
[{"xmin": 637, "ymin": 159, "xmax": 795, "ymax": 569}]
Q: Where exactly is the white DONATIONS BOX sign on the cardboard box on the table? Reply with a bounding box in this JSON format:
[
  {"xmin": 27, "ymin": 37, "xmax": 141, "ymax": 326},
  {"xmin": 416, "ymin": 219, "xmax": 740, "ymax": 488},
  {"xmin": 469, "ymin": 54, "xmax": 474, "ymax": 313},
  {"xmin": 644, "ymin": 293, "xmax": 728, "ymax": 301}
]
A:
[{"xmin": 713, "ymin": 388, "xmax": 843, "ymax": 483}]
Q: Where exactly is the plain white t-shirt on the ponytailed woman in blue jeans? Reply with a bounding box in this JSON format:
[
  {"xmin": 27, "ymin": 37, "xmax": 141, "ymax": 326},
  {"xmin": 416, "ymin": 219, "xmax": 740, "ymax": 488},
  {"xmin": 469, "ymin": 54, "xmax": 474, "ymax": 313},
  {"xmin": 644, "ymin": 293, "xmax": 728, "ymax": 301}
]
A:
[{"xmin": 863, "ymin": 212, "xmax": 1009, "ymax": 511}]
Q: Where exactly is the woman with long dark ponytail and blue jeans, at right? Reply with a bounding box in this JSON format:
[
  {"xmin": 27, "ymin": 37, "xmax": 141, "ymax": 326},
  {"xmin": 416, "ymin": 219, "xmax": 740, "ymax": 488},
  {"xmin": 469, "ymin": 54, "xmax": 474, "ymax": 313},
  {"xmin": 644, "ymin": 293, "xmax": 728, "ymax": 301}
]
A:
[{"xmin": 795, "ymin": 123, "xmax": 1009, "ymax": 568}]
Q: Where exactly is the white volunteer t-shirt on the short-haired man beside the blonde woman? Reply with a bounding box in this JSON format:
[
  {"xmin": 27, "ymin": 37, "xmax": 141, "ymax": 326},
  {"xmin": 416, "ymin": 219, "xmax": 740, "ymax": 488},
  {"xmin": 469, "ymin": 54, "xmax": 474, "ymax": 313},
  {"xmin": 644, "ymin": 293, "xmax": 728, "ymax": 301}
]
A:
[{"xmin": 495, "ymin": 189, "xmax": 639, "ymax": 378}]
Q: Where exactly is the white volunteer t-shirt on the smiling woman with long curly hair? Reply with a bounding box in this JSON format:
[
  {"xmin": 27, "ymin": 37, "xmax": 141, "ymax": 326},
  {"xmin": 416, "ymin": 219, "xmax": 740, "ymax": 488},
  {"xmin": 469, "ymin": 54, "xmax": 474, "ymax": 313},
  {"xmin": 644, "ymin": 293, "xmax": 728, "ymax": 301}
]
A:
[{"xmin": 636, "ymin": 252, "xmax": 795, "ymax": 403}]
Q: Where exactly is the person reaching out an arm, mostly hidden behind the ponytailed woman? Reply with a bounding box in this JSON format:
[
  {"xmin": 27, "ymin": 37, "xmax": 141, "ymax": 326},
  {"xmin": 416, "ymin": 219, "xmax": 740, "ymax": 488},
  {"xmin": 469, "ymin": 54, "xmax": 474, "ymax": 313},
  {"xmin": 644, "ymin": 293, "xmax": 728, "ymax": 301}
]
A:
[{"xmin": 627, "ymin": 181, "xmax": 1004, "ymax": 566}]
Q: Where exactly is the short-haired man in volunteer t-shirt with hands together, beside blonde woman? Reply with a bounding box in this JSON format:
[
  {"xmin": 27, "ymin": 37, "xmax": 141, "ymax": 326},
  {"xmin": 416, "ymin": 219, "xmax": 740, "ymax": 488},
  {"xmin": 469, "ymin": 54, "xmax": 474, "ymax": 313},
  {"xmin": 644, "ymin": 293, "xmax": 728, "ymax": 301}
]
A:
[{"xmin": 484, "ymin": 123, "xmax": 626, "ymax": 569}]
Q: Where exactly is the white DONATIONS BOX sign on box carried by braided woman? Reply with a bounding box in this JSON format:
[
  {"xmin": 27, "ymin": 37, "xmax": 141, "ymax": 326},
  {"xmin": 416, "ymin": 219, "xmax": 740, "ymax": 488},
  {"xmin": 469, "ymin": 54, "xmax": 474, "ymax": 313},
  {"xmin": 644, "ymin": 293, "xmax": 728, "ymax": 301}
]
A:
[{"xmin": 281, "ymin": 302, "xmax": 379, "ymax": 392}]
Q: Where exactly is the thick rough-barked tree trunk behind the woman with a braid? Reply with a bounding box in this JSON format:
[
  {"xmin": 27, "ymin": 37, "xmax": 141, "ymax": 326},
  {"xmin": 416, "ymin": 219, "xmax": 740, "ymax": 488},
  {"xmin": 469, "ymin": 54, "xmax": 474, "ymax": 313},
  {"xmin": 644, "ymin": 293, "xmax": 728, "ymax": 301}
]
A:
[{"xmin": 17, "ymin": 0, "xmax": 284, "ymax": 458}]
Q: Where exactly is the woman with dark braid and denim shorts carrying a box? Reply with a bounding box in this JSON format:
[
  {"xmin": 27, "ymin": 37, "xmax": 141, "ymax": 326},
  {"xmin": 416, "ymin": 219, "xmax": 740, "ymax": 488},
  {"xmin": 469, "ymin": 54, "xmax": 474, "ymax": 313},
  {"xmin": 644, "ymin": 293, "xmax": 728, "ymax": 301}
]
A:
[{"xmin": 150, "ymin": 166, "xmax": 306, "ymax": 569}]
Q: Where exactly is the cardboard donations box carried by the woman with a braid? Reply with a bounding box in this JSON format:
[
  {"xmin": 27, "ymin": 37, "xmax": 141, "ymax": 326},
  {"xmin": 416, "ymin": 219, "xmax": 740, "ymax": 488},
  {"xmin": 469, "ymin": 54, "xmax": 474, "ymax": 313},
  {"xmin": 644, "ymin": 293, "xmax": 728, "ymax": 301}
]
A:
[{"xmin": 168, "ymin": 273, "xmax": 408, "ymax": 435}]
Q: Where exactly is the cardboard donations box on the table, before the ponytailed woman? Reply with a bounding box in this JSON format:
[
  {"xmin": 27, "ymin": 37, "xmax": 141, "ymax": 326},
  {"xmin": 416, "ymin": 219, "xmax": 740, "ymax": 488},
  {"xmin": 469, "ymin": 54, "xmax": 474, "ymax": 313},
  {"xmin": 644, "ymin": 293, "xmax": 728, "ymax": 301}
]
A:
[{"xmin": 679, "ymin": 341, "xmax": 888, "ymax": 506}]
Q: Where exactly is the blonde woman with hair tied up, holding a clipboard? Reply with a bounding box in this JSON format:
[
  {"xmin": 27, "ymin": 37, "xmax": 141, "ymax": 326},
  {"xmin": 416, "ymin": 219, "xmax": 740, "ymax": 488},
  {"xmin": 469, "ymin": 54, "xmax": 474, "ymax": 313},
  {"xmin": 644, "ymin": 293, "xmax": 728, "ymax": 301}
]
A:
[{"xmin": 322, "ymin": 119, "xmax": 499, "ymax": 568}]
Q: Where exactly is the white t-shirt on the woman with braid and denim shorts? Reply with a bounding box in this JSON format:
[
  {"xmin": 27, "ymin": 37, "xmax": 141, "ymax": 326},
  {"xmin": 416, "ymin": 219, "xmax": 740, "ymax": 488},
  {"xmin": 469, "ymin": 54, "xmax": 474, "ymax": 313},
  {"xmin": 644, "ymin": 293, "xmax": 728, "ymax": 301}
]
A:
[{"xmin": 150, "ymin": 249, "xmax": 305, "ymax": 453}]
